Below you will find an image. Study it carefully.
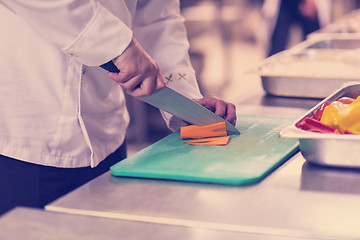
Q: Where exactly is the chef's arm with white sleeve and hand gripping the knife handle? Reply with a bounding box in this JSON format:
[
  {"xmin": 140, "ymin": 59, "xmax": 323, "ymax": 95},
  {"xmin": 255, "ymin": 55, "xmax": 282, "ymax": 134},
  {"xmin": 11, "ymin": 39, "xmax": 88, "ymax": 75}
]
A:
[{"xmin": 0, "ymin": 0, "xmax": 165, "ymax": 96}]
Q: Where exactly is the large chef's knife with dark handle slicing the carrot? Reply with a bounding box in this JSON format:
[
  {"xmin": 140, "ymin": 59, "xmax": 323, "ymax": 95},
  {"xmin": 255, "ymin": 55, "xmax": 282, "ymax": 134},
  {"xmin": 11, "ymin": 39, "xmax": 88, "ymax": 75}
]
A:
[{"xmin": 100, "ymin": 61, "xmax": 240, "ymax": 135}]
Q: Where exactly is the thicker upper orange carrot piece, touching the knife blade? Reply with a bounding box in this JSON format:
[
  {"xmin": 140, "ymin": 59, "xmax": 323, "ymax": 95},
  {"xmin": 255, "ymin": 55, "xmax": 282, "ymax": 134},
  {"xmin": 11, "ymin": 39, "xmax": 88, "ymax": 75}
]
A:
[{"xmin": 180, "ymin": 122, "xmax": 227, "ymax": 139}]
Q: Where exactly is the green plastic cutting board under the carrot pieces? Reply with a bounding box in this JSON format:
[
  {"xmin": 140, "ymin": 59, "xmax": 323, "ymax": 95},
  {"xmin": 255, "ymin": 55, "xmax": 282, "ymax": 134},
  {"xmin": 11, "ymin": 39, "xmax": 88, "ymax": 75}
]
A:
[{"xmin": 110, "ymin": 115, "xmax": 298, "ymax": 185}]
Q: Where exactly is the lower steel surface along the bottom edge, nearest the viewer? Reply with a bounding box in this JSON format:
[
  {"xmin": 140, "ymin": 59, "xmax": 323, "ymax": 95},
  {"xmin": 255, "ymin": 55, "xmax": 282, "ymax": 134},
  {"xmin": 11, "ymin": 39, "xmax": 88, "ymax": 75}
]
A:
[{"xmin": 0, "ymin": 208, "xmax": 302, "ymax": 240}]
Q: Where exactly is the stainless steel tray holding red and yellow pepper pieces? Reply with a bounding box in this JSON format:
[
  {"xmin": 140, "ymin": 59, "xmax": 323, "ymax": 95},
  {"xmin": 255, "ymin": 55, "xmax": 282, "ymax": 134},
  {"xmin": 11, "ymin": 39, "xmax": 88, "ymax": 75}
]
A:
[{"xmin": 280, "ymin": 82, "xmax": 360, "ymax": 168}]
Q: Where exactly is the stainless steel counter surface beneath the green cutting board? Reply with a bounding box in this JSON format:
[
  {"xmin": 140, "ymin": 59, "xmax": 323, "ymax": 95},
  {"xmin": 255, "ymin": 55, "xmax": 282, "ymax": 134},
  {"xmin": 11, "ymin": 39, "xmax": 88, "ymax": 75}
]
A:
[{"xmin": 46, "ymin": 93, "xmax": 360, "ymax": 239}]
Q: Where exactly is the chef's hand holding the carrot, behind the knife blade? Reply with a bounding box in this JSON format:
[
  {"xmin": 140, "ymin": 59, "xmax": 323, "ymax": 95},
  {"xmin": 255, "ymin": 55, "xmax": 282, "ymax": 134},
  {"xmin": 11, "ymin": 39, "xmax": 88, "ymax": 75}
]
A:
[{"xmin": 193, "ymin": 95, "xmax": 236, "ymax": 126}]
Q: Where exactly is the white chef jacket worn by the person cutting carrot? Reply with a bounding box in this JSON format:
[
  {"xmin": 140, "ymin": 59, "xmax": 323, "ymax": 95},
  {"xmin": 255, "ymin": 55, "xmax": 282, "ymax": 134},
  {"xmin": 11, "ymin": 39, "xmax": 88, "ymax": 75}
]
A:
[{"xmin": 0, "ymin": 0, "xmax": 201, "ymax": 167}]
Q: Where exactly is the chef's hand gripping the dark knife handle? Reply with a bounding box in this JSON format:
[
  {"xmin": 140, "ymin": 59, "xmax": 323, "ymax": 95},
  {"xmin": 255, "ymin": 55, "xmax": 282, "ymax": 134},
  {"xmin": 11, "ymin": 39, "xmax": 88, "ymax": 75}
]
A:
[{"xmin": 109, "ymin": 38, "xmax": 165, "ymax": 97}]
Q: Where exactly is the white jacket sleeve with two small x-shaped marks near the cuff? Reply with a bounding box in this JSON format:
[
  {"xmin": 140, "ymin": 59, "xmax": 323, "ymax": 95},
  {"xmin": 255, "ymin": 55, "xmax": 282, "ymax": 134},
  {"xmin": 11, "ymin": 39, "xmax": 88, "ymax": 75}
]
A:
[{"xmin": 133, "ymin": 0, "xmax": 202, "ymax": 130}]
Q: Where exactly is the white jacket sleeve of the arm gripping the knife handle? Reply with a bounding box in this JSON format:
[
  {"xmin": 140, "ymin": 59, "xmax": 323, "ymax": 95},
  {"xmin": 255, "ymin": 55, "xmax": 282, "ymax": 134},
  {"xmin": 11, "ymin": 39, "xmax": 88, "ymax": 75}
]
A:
[{"xmin": 0, "ymin": 0, "xmax": 132, "ymax": 66}]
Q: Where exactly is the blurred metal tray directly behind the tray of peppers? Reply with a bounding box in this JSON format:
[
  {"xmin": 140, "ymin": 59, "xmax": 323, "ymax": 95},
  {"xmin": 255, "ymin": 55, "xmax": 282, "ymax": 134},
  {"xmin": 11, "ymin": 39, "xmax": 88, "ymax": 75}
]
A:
[{"xmin": 259, "ymin": 36, "xmax": 360, "ymax": 98}]
